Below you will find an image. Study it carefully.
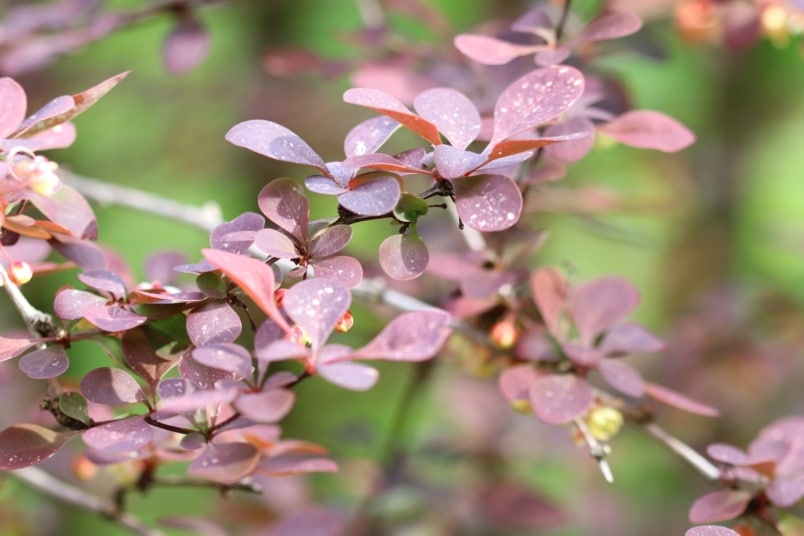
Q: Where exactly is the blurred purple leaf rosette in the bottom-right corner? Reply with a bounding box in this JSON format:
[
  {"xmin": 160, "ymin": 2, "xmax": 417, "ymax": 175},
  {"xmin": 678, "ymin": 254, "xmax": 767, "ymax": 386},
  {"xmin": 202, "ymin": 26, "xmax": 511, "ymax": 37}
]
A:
[{"xmin": 689, "ymin": 416, "xmax": 804, "ymax": 536}]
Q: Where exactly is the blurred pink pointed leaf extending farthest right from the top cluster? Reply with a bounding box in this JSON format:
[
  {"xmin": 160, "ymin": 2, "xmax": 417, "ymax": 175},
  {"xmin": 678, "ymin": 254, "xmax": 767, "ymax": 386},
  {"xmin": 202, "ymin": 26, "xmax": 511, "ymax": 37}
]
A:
[{"xmin": 598, "ymin": 110, "xmax": 695, "ymax": 153}]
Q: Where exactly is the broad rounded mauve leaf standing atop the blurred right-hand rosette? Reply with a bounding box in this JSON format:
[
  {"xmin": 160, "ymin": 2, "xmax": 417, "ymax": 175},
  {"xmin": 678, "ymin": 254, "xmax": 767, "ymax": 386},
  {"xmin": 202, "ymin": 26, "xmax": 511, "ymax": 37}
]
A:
[{"xmin": 569, "ymin": 277, "xmax": 639, "ymax": 345}]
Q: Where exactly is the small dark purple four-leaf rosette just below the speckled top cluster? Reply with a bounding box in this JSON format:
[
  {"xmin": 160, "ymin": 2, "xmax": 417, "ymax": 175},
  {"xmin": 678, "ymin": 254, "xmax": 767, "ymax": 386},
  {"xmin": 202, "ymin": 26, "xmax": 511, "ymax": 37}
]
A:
[{"xmin": 254, "ymin": 178, "xmax": 363, "ymax": 288}]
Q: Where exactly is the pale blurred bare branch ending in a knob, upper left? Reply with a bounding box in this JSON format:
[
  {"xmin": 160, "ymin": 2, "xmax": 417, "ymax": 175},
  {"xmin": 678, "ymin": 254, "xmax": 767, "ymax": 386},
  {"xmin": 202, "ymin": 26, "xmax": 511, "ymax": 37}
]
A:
[{"xmin": 64, "ymin": 173, "xmax": 223, "ymax": 232}]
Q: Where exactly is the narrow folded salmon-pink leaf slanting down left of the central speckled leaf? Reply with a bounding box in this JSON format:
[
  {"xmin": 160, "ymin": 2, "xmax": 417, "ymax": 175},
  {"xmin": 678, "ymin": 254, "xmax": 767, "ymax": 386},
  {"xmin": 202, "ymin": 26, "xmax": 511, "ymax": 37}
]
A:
[{"xmin": 201, "ymin": 249, "xmax": 290, "ymax": 331}]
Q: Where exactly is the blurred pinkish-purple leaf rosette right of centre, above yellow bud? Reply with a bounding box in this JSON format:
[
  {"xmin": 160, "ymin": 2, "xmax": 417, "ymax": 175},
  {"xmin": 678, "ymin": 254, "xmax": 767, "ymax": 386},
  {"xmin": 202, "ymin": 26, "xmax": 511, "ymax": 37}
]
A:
[{"xmin": 500, "ymin": 268, "xmax": 717, "ymax": 424}]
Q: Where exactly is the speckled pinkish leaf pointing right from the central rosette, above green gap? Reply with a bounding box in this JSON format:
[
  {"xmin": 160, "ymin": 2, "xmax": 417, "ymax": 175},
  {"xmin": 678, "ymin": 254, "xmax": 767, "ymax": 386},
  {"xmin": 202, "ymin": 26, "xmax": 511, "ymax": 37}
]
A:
[{"xmin": 352, "ymin": 309, "xmax": 451, "ymax": 361}]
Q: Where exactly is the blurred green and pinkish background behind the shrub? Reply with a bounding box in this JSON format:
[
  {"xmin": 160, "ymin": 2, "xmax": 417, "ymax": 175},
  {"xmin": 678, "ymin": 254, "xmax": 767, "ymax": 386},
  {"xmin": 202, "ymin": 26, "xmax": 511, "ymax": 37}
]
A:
[{"xmin": 0, "ymin": 0, "xmax": 804, "ymax": 536}]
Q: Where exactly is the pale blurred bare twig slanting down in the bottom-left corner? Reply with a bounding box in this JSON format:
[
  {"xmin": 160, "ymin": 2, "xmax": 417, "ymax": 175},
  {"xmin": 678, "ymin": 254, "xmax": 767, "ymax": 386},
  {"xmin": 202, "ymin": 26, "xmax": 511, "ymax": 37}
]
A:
[{"xmin": 10, "ymin": 467, "xmax": 164, "ymax": 536}]
